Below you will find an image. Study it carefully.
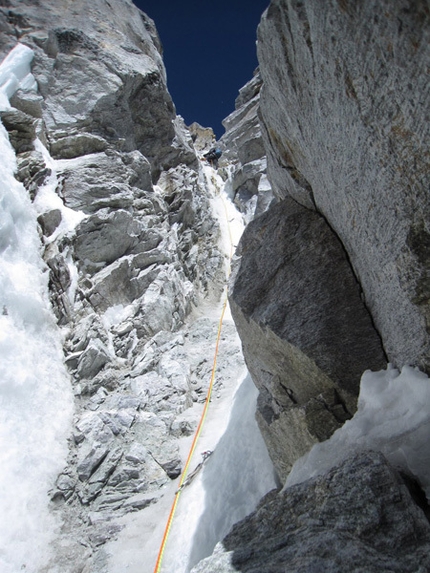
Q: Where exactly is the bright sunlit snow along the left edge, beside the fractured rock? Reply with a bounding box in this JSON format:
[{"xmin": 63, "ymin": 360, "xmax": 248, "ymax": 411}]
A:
[{"xmin": 0, "ymin": 45, "xmax": 73, "ymax": 573}]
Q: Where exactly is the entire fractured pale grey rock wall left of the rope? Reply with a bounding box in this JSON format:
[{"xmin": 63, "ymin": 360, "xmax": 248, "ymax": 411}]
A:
[{"xmin": 0, "ymin": 0, "xmax": 244, "ymax": 573}]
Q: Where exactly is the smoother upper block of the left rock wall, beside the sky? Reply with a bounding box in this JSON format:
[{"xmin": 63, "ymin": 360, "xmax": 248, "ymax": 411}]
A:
[{"xmin": 2, "ymin": 0, "xmax": 196, "ymax": 179}]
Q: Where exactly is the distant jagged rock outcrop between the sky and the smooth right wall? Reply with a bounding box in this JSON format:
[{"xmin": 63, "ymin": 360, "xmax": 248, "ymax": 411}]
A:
[{"xmin": 220, "ymin": 70, "xmax": 273, "ymax": 222}]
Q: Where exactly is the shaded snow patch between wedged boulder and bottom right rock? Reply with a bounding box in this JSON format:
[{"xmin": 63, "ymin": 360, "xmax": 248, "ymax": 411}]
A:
[{"xmin": 286, "ymin": 366, "xmax": 430, "ymax": 501}]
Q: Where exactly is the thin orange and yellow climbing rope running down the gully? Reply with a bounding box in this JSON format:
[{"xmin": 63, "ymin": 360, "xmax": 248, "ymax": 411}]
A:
[{"xmin": 154, "ymin": 168, "xmax": 233, "ymax": 573}]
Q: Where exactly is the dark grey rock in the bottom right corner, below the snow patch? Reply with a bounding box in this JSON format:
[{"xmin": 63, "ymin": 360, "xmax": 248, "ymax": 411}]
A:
[{"xmin": 192, "ymin": 452, "xmax": 430, "ymax": 573}]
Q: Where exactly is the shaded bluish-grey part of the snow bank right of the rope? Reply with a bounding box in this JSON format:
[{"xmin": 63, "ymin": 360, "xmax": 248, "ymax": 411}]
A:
[{"xmin": 188, "ymin": 375, "xmax": 277, "ymax": 569}]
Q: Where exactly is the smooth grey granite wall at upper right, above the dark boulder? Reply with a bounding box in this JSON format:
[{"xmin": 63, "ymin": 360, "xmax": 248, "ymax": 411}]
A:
[{"xmin": 258, "ymin": 0, "xmax": 430, "ymax": 371}]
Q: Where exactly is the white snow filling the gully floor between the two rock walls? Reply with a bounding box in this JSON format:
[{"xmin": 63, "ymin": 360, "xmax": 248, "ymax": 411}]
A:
[{"xmin": 105, "ymin": 165, "xmax": 276, "ymax": 573}]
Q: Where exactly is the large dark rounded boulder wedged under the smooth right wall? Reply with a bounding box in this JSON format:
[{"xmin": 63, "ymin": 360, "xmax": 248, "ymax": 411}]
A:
[{"xmin": 230, "ymin": 199, "xmax": 385, "ymax": 480}]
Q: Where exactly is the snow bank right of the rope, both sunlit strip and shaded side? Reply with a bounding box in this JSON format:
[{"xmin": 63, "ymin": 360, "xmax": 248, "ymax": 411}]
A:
[{"xmin": 159, "ymin": 370, "xmax": 275, "ymax": 573}]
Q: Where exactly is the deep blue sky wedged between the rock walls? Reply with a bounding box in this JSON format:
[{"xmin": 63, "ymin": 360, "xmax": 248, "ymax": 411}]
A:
[{"xmin": 133, "ymin": 0, "xmax": 269, "ymax": 138}]
